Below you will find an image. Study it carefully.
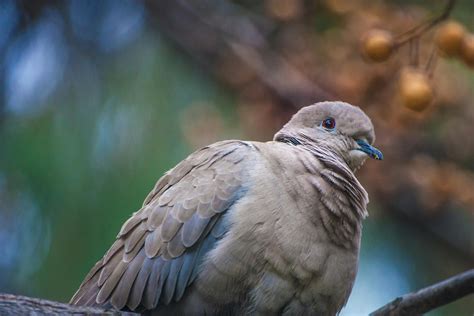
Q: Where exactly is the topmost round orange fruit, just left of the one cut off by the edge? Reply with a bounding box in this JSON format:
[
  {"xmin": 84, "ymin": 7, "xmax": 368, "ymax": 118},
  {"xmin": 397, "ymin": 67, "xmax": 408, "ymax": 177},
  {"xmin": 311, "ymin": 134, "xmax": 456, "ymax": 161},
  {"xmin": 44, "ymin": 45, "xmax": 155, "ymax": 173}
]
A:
[{"xmin": 436, "ymin": 21, "xmax": 465, "ymax": 56}]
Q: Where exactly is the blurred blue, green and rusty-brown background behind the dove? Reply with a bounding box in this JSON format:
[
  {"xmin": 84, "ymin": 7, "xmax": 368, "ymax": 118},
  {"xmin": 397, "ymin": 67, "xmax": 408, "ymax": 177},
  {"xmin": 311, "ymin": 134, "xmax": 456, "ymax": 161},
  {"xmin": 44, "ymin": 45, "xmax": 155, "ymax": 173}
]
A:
[{"xmin": 0, "ymin": 0, "xmax": 474, "ymax": 315}]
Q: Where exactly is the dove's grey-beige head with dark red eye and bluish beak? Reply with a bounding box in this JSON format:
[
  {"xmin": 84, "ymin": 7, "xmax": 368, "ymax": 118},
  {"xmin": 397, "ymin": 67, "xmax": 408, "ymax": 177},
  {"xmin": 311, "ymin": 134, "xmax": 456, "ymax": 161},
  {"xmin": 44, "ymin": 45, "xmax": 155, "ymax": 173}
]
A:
[{"xmin": 274, "ymin": 101, "xmax": 383, "ymax": 171}]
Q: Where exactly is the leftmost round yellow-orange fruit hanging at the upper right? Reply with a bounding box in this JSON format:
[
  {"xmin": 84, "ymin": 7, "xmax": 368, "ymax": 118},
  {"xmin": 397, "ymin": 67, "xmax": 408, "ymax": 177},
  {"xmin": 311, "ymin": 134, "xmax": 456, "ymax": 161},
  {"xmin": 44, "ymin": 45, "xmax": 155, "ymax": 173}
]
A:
[{"xmin": 362, "ymin": 30, "xmax": 394, "ymax": 62}]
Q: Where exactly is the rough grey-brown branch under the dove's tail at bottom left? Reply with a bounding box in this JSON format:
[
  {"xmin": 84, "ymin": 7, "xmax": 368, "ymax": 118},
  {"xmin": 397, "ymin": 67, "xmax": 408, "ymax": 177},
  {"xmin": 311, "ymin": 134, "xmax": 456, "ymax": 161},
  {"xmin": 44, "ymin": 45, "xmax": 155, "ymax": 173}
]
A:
[{"xmin": 0, "ymin": 294, "xmax": 138, "ymax": 316}]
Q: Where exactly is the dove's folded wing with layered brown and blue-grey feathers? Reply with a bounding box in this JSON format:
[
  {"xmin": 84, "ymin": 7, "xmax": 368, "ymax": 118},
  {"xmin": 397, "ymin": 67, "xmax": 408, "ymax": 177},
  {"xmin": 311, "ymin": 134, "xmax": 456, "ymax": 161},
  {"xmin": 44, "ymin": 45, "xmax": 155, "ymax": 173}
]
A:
[{"xmin": 71, "ymin": 141, "xmax": 253, "ymax": 310}]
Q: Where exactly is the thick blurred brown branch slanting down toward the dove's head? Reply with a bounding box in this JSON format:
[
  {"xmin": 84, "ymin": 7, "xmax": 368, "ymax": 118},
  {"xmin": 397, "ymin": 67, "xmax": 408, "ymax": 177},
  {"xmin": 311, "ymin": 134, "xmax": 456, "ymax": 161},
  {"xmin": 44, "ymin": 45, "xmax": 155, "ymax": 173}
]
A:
[{"xmin": 147, "ymin": 0, "xmax": 336, "ymax": 107}]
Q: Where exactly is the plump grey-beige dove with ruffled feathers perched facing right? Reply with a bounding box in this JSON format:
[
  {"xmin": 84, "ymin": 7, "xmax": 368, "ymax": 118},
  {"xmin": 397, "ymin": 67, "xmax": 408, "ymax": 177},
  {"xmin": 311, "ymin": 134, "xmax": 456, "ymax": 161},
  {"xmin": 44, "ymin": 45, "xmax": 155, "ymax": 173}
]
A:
[{"xmin": 71, "ymin": 101, "xmax": 383, "ymax": 315}]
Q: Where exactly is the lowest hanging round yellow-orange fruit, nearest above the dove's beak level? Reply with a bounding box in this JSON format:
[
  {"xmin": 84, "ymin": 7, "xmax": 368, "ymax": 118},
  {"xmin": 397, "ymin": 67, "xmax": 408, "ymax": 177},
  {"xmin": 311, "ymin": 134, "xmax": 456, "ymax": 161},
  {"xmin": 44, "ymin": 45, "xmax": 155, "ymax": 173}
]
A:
[{"xmin": 400, "ymin": 69, "xmax": 433, "ymax": 112}]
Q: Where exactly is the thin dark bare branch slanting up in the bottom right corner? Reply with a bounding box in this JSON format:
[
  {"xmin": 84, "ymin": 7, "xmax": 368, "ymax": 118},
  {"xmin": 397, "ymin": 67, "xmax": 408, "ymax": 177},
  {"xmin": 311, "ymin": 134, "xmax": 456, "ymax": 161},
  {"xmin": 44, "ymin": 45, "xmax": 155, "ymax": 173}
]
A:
[{"xmin": 370, "ymin": 269, "xmax": 474, "ymax": 316}]
